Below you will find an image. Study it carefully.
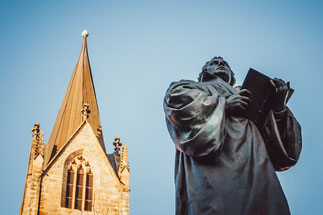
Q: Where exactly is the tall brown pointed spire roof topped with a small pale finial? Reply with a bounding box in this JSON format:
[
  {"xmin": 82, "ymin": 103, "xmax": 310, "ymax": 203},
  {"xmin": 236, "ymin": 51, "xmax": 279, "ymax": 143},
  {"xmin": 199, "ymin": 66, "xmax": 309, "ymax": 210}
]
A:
[{"xmin": 45, "ymin": 30, "xmax": 105, "ymax": 165}]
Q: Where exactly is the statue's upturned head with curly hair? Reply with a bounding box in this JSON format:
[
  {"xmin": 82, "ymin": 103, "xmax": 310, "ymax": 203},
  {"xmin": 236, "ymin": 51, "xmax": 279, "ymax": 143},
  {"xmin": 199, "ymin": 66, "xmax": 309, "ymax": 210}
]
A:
[{"xmin": 198, "ymin": 56, "xmax": 236, "ymax": 86}]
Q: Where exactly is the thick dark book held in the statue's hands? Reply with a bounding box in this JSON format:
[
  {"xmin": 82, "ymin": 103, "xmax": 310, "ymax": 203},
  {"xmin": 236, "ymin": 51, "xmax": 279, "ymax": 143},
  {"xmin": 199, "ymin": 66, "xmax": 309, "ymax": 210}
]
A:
[{"xmin": 241, "ymin": 68, "xmax": 294, "ymax": 128}]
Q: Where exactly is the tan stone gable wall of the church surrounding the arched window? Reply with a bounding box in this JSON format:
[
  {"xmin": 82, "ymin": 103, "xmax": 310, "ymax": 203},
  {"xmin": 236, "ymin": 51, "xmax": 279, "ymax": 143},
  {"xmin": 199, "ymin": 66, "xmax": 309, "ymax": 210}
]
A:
[{"xmin": 39, "ymin": 123, "xmax": 129, "ymax": 215}]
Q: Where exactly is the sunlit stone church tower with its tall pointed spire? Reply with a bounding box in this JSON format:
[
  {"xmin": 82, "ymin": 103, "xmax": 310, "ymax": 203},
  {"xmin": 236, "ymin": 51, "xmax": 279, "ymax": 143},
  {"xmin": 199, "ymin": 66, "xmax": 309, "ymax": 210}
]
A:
[{"xmin": 20, "ymin": 30, "xmax": 130, "ymax": 215}]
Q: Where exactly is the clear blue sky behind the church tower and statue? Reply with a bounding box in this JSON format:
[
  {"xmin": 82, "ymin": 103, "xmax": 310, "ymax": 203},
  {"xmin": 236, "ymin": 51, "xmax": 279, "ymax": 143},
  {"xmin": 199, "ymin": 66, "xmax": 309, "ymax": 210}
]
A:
[{"xmin": 0, "ymin": 0, "xmax": 323, "ymax": 215}]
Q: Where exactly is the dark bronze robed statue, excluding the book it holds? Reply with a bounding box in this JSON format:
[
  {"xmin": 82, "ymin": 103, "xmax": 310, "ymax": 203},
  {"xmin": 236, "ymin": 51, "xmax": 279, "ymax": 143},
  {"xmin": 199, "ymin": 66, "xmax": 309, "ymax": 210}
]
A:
[{"xmin": 164, "ymin": 57, "xmax": 302, "ymax": 215}]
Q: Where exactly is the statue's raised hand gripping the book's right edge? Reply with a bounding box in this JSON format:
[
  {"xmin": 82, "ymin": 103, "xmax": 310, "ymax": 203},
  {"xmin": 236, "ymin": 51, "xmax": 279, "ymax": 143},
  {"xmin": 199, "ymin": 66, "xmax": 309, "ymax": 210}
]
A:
[{"xmin": 270, "ymin": 78, "xmax": 290, "ymax": 112}]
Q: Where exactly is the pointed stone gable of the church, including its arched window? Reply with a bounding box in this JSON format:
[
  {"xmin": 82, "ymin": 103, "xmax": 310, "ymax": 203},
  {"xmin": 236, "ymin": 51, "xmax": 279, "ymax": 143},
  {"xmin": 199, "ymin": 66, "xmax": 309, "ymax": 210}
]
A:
[{"xmin": 40, "ymin": 122, "xmax": 129, "ymax": 215}]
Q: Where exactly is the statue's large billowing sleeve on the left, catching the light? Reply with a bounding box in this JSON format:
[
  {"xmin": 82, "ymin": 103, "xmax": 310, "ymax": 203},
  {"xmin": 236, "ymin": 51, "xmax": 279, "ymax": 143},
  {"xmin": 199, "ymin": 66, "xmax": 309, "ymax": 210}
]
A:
[{"xmin": 164, "ymin": 81, "xmax": 225, "ymax": 160}]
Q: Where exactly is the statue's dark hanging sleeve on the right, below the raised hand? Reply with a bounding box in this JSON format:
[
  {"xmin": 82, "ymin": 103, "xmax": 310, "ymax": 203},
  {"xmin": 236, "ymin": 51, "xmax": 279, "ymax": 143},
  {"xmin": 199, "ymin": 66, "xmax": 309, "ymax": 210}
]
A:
[{"xmin": 264, "ymin": 108, "xmax": 302, "ymax": 171}]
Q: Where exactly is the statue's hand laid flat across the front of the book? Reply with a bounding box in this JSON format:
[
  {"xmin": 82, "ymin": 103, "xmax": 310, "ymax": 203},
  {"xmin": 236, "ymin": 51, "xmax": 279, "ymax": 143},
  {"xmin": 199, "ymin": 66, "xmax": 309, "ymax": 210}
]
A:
[{"xmin": 225, "ymin": 89, "xmax": 251, "ymax": 116}]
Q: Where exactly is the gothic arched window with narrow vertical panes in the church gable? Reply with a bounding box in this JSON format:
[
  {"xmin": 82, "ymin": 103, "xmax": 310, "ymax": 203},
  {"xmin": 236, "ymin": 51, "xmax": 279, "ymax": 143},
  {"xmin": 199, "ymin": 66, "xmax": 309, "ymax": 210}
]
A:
[{"xmin": 62, "ymin": 155, "xmax": 93, "ymax": 211}]
